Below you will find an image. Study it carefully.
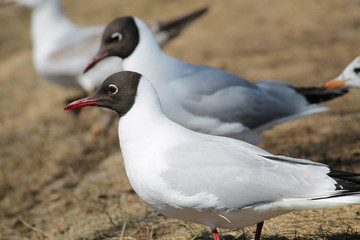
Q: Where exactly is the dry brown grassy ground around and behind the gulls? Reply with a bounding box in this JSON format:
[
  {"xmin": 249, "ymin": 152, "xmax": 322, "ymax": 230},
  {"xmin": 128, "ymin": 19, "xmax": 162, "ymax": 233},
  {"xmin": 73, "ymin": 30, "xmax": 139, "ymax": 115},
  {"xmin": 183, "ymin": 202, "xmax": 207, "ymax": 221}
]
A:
[{"xmin": 0, "ymin": 0, "xmax": 360, "ymax": 240}]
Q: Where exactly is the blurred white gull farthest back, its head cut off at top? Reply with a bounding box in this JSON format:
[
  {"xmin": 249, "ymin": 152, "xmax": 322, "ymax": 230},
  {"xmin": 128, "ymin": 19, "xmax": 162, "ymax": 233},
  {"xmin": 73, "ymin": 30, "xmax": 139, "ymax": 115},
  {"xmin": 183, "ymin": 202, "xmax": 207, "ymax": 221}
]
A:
[{"xmin": 7, "ymin": 0, "xmax": 207, "ymax": 92}]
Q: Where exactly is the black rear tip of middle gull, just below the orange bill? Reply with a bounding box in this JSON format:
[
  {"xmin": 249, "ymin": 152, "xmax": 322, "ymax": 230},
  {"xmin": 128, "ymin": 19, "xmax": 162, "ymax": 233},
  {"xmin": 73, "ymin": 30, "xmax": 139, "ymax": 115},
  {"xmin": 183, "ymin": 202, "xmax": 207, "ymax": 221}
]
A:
[{"xmin": 294, "ymin": 87, "xmax": 348, "ymax": 104}]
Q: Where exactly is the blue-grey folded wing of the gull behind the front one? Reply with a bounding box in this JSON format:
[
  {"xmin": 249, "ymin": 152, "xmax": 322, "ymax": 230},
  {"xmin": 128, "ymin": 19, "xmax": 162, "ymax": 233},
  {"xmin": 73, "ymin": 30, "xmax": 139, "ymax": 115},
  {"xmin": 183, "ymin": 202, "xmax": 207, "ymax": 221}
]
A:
[{"xmin": 171, "ymin": 68, "xmax": 307, "ymax": 129}]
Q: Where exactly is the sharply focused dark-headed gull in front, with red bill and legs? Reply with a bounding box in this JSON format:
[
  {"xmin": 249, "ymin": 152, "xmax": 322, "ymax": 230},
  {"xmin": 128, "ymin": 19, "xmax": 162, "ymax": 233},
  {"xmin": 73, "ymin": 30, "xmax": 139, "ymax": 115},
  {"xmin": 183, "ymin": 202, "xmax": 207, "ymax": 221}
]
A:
[{"xmin": 65, "ymin": 71, "xmax": 360, "ymax": 240}]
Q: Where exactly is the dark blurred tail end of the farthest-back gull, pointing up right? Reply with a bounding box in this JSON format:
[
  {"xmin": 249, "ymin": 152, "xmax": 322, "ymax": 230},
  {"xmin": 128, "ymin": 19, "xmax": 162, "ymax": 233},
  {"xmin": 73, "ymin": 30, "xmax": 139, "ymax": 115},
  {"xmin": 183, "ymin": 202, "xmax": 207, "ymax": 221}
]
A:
[{"xmin": 149, "ymin": 7, "xmax": 208, "ymax": 47}]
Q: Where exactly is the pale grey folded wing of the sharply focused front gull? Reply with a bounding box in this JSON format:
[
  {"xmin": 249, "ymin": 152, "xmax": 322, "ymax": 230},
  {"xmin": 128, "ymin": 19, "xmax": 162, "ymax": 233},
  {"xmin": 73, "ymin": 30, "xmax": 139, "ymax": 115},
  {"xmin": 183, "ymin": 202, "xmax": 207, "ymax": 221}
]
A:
[{"xmin": 160, "ymin": 135, "xmax": 335, "ymax": 211}]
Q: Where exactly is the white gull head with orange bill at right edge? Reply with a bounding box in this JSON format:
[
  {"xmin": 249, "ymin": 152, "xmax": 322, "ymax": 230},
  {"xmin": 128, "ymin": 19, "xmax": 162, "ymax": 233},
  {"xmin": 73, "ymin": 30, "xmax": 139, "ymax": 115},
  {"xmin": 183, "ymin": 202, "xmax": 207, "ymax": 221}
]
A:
[{"xmin": 324, "ymin": 57, "xmax": 360, "ymax": 89}]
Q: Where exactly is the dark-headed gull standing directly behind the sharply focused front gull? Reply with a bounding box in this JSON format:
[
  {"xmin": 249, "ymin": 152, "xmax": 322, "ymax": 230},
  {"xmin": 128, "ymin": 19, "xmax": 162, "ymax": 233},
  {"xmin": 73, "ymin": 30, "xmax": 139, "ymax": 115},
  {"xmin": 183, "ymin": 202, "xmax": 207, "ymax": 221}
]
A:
[{"xmin": 85, "ymin": 17, "xmax": 345, "ymax": 143}]
